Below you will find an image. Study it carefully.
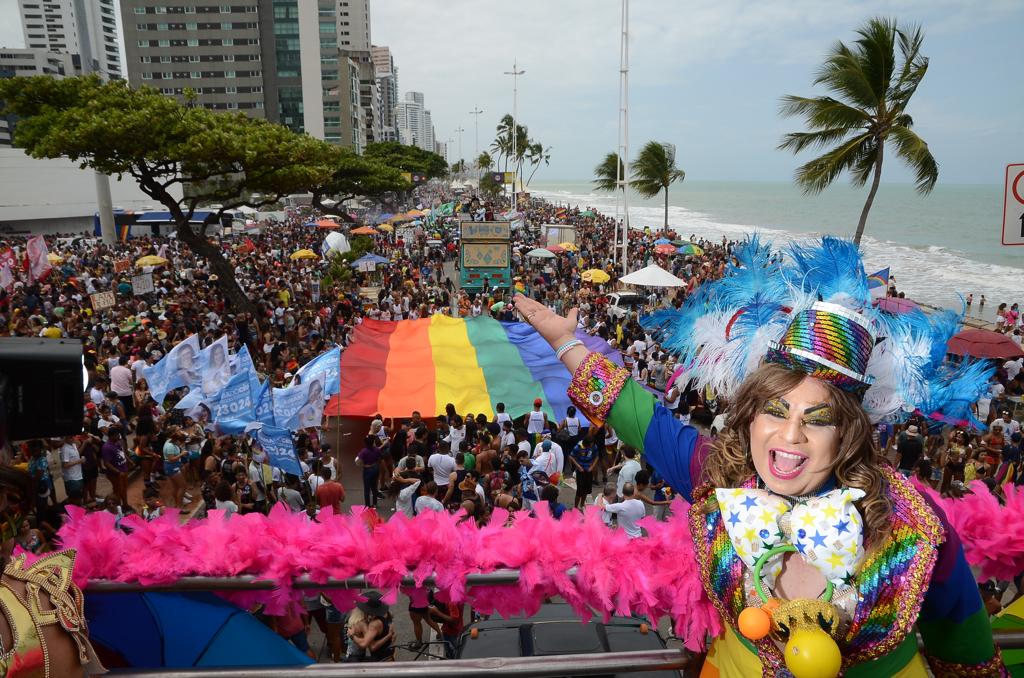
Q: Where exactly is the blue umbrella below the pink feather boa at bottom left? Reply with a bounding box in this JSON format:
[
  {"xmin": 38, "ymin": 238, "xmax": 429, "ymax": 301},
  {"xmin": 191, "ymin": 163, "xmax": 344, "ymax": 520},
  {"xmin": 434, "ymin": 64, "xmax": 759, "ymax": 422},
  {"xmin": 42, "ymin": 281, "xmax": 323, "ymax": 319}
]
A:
[{"xmin": 85, "ymin": 592, "xmax": 313, "ymax": 668}]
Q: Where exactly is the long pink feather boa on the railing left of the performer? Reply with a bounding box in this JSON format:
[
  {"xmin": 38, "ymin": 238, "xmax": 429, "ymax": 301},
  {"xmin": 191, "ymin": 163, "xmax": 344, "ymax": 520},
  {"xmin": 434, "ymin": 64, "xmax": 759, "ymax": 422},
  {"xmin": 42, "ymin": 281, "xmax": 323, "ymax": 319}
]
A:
[{"xmin": 59, "ymin": 499, "xmax": 722, "ymax": 649}]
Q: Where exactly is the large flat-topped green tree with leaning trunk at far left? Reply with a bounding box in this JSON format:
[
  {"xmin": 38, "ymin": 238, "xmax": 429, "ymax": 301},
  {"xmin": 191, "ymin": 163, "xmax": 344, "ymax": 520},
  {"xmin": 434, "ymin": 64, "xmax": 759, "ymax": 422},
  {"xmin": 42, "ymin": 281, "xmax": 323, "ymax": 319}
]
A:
[{"xmin": 0, "ymin": 76, "xmax": 333, "ymax": 312}]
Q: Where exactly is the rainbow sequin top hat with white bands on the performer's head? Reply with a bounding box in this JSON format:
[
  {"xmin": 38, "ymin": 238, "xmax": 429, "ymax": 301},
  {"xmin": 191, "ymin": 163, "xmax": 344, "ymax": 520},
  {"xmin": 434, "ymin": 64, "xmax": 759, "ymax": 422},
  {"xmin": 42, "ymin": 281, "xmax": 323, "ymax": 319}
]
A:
[{"xmin": 765, "ymin": 301, "xmax": 877, "ymax": 393}]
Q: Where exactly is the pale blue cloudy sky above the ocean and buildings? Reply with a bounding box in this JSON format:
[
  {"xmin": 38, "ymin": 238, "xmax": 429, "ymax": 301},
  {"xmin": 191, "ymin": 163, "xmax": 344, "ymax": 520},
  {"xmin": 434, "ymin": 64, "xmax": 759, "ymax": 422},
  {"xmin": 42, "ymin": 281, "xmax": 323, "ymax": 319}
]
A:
[{"xmin": 0, "ymin": 0, "xmax": 1024, "ymax": 184}]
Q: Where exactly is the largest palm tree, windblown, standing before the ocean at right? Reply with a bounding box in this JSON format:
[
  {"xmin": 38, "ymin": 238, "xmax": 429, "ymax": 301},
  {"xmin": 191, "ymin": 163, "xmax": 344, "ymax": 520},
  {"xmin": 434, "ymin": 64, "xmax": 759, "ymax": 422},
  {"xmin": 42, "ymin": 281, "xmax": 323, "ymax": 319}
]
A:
[{"xmin": 778, "ymin": 18, "xmax": 939, "ymax": 245}]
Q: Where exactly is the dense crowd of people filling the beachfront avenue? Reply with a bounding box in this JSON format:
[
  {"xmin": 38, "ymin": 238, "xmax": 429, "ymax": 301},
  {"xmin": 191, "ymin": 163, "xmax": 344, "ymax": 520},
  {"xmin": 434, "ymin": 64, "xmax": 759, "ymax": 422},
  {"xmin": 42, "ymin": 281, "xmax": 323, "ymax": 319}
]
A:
[{"xmin": 0, "ymin": 184, "xmax": 1024, "ymax": 661}]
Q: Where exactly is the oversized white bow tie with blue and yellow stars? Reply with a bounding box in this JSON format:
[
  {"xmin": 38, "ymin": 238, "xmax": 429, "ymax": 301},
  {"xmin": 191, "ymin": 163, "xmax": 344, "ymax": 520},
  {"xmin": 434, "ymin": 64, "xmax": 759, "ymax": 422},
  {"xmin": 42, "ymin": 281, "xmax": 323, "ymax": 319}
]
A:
[{"xmin": 715, "ymin": 488, "xmax": 864, "ymax": 586}]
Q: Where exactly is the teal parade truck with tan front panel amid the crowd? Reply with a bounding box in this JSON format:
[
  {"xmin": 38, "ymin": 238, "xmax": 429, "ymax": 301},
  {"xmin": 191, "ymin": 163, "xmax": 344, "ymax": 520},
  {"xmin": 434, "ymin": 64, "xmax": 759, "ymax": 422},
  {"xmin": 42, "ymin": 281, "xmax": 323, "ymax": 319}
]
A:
[{"xmin": 459, "ymin": 221, "xmax": 512, "ymax": 292}]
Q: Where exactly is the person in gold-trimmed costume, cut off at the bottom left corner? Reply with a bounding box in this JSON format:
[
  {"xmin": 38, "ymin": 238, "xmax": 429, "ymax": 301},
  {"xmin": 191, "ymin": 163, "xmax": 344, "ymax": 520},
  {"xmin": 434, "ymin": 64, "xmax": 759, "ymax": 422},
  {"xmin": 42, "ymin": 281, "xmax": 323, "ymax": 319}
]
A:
[{"xmin": 0, "ymin": 466, "xmax": 104, "ymax": 678}]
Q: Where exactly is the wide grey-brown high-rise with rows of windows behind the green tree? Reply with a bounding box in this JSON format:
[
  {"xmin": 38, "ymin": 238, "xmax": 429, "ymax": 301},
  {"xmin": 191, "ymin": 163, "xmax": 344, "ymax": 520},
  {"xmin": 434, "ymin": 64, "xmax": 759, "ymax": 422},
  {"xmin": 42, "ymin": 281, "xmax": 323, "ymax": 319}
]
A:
[{"xmin": 121, "ymin": 0, "xmax": 264, "ymax": 118}]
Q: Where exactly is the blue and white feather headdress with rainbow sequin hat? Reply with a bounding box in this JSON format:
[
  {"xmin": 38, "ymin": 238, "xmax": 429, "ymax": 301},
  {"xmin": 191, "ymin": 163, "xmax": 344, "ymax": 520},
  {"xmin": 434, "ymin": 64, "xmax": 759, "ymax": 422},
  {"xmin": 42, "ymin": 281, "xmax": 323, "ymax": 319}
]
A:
[{"xmin": 641, "ymin": 236, "xmax": 992, "ymax": 424}]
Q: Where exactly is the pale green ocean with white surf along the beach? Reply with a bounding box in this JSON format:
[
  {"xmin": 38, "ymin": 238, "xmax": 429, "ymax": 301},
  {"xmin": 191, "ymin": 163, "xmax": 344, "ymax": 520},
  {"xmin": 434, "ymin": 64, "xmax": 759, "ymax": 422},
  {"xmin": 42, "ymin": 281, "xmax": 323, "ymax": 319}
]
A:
[{"xmin": 530, "ymin": 181, "xmax": 1024, "ymax": 320}]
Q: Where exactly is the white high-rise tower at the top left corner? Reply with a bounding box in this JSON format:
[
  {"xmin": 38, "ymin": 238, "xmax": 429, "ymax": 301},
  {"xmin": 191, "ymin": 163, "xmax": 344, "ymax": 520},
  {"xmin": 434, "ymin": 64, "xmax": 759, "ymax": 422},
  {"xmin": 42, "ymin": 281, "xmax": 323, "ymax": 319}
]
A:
[{"xmin": 17, "ymin": 0, "xmax": 122, "ymax": 80}]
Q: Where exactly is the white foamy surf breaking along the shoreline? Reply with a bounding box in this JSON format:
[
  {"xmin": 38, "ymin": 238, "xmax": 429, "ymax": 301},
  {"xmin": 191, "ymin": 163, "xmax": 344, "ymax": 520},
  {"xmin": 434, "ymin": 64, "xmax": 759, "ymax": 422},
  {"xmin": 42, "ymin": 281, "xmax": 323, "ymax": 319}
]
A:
[{"xmin": 534, "ymin": 186, "xmax": 1024, "ymax": 316}]
